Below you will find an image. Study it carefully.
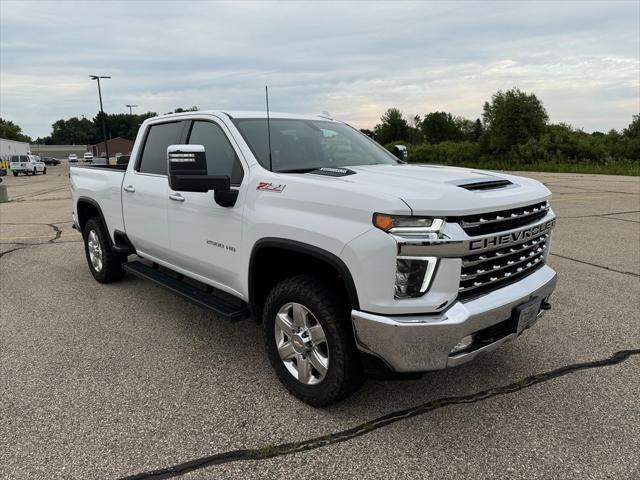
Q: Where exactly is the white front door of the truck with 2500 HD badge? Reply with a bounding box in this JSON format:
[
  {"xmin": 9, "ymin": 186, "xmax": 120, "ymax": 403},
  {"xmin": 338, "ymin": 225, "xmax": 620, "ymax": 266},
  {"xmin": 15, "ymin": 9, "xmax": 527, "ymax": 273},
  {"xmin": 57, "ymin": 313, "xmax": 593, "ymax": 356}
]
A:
[{"xmin": 168, "ymin": 119, "xmax": 248, "ymax": 293}]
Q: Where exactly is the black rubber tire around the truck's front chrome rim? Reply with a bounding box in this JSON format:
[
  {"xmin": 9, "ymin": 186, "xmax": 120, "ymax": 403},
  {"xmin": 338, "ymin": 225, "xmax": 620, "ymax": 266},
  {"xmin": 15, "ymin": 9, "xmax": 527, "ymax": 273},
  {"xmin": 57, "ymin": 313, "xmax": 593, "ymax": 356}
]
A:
[{"xmin": 262, "ymin": 275, "xmax": 364, "ymax": 407}]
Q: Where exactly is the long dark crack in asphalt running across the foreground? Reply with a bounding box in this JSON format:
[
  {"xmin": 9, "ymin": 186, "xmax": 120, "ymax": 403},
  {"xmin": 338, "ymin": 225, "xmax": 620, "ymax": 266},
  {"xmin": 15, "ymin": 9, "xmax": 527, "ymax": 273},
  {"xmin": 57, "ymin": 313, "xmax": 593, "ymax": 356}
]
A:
[{"xmin": 121, "ymin": 349, "xmax": 640, "ymax": 480}]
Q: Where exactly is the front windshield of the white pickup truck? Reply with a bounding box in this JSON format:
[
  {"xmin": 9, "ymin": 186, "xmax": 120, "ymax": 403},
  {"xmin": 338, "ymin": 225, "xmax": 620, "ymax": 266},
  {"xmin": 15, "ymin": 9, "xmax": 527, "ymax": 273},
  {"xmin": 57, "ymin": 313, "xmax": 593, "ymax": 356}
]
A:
[{"xmin": 233, "ymin": 118, "xmax": 398, "ymax": 172}]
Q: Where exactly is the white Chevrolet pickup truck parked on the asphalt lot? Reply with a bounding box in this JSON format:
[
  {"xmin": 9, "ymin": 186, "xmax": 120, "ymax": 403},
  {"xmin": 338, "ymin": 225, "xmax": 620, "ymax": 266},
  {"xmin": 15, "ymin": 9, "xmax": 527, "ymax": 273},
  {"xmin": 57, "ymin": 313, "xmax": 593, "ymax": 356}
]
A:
[{"xmin": 70, "ymin": 111, "xmax": 556, "ymax": 406}]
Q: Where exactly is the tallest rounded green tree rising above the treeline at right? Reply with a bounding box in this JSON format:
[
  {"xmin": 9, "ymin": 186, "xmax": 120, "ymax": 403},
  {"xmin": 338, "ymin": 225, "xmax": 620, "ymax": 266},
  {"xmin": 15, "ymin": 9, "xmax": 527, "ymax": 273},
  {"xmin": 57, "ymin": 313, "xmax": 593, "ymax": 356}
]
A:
[{"xmin": 482, "ymin": 88, "xmax": 549, "ymax": 155}]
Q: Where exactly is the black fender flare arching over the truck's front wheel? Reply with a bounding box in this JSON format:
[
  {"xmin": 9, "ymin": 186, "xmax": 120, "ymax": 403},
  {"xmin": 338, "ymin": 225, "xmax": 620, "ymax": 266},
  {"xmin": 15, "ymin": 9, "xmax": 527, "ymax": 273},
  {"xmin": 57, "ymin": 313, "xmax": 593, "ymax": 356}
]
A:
[{"xmin": 249, "ymin": 237, "xmax": 360, "ymax": 310}]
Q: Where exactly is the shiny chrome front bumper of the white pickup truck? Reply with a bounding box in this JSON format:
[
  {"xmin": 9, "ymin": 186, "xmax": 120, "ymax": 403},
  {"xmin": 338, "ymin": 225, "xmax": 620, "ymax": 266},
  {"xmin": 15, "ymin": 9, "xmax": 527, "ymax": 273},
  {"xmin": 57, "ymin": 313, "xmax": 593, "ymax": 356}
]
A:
[{"xmin": 351, "ymin": 265, "xmax": 556, "ymax": 372}]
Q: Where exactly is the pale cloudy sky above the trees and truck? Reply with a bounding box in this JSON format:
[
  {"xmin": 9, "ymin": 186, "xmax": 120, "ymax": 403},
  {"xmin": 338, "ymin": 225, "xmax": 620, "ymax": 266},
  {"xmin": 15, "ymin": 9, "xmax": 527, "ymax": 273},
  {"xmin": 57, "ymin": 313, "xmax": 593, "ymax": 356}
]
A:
[{"xmin": 0, "ymin": 0, "xmax": 640, "ymax": 138}]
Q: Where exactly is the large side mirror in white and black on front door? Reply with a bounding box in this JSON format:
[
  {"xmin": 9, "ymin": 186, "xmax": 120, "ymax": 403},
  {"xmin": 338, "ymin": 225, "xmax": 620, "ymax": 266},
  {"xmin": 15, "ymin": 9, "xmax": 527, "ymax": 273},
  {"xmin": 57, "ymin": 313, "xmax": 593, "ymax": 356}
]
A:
[{"xmin": 167, "ymin": 145, "xmax": 238, "ymax": 207}]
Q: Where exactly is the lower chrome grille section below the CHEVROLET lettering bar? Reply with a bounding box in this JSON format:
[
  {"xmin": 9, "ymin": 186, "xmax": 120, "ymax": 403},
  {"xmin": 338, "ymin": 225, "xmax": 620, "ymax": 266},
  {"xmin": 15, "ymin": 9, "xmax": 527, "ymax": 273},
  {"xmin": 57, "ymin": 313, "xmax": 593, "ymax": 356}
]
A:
[{"xmin": 458, "ymin": 233, "xmax": 549, "ymax": 298}]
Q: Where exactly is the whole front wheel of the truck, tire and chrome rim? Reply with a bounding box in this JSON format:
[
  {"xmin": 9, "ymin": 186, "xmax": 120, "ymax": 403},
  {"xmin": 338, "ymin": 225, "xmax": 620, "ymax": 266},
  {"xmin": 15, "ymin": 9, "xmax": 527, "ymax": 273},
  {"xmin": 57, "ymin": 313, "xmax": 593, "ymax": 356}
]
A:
[{"xmin": 263, "ymin": 275, "xmax": 364, "ymax": 407}]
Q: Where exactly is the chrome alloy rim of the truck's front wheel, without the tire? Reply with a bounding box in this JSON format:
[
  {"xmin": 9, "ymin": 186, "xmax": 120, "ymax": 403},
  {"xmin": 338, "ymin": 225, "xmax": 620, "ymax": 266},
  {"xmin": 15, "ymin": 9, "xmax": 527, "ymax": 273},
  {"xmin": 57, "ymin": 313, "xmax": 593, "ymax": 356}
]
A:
[{"xmin": 274, "ymin": 302, "xmax": 329, "ymax": 385}]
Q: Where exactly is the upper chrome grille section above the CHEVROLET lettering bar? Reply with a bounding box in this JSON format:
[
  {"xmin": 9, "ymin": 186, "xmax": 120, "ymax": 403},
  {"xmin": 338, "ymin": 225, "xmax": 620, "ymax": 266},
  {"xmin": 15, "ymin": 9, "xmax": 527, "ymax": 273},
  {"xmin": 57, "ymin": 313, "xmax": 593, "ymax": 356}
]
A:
[{"xmin": 447, "ymin": 201, "xmax": 549, "ymax": 237}]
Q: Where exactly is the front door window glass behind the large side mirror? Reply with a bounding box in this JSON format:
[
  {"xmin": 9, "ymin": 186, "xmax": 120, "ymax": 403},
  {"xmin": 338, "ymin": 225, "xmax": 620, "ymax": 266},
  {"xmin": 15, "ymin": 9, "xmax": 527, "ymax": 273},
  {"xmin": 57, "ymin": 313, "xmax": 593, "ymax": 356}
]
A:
[{"xmin": 189, "ymin": 121, "xmax": 244, "ymax": 185}]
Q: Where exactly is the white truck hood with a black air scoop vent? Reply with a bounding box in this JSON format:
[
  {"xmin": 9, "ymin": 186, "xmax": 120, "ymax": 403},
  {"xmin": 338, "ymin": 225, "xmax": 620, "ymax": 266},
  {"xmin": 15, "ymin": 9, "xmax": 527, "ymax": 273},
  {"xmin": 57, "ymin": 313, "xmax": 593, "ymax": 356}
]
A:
[{"xmin": 327, "ymin": 164, "xmax": 551, "ymax": 216}]
